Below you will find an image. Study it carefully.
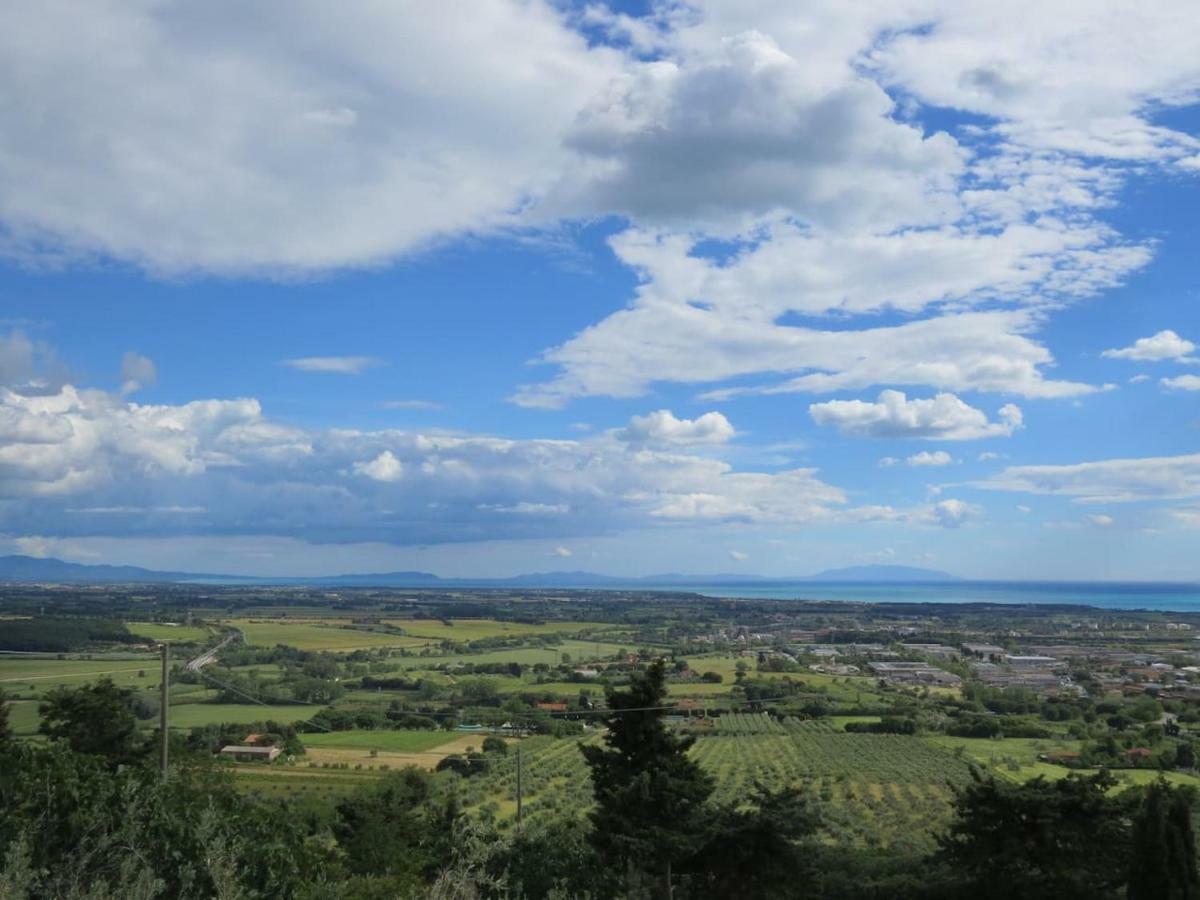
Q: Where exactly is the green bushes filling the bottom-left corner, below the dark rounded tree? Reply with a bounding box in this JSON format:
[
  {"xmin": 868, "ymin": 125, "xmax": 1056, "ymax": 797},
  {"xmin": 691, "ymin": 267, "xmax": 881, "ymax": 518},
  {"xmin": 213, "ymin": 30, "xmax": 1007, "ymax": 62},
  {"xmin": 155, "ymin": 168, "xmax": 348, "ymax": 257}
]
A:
[{"xmin": 0, "ymin": 744, "xmax": 325, "ymax": 900}]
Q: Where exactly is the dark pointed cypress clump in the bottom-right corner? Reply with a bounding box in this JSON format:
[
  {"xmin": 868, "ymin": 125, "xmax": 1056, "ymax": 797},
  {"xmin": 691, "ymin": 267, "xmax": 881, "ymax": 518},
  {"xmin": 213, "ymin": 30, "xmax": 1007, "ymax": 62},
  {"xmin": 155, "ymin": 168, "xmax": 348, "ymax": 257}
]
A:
[{"xmin": 1127, "ymin": 778, "xmax": 1200, "ymax": 900}]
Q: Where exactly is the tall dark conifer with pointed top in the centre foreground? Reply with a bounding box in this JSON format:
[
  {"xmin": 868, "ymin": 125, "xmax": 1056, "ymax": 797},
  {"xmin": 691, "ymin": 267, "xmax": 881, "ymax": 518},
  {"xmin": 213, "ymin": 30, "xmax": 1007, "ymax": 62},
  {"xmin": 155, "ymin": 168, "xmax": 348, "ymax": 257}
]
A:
[{"xmin": 580, "ymin": 660, "xmax": 713, "ymax": 896}]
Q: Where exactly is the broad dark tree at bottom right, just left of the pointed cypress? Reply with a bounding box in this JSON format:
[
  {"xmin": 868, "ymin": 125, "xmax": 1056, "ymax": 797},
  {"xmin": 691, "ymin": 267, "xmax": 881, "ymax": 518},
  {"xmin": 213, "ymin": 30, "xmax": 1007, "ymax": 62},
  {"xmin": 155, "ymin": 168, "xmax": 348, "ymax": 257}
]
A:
[{"xmin": 941, "ymin": 770, "xmax": 1129, "ymax": 900}]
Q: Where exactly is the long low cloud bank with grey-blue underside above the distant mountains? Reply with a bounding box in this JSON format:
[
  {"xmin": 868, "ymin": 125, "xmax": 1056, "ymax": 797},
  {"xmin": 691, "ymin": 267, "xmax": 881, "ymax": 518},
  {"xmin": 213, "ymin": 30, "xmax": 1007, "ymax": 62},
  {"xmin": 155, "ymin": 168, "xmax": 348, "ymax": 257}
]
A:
[{"xmin": 0, "ymin": 374, "xmax": 988, "ymax": 544}]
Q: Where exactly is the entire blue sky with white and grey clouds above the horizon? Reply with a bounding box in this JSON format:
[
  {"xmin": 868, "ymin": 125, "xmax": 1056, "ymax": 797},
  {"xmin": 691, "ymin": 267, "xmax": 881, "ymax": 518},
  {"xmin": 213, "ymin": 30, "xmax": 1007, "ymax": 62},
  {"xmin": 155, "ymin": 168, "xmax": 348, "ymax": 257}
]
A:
[{"xmin": 0, "ymin": 0, "xmax": 1200, "ymax": 581}]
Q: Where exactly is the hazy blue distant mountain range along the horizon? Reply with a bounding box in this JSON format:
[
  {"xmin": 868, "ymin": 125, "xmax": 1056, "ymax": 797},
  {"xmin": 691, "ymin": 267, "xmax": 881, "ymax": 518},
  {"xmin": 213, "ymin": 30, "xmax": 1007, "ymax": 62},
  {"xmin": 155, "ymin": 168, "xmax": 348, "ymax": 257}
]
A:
[{"xmin": 0, "ymin": 556, "xmax": 959, "ymax": 589}]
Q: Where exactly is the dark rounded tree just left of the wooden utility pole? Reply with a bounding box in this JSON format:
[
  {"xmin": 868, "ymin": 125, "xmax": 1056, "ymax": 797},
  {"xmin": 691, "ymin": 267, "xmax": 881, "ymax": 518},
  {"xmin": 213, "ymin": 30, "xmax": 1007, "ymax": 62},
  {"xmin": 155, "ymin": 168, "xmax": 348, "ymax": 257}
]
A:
[{"xmin": 37, "ymin": 678, "xmax": 146, "ymax": 766}]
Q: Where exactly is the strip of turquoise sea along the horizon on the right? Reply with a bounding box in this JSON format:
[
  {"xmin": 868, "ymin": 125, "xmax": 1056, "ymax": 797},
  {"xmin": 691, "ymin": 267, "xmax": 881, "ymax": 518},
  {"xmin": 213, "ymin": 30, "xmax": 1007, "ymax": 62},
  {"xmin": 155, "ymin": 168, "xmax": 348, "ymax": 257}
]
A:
[{"xmin": 637, "ymin": 581, "xmax": 1200, "ymax": 612}]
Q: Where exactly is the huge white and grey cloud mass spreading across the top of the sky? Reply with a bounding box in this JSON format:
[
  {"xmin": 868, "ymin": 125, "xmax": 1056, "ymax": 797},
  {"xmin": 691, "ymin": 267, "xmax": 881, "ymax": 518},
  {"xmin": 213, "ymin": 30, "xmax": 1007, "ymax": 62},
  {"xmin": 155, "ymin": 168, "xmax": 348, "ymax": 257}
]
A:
[{"xmin": 0, "ymin": 0, "xmax": 1200, "ymax": 406}]
